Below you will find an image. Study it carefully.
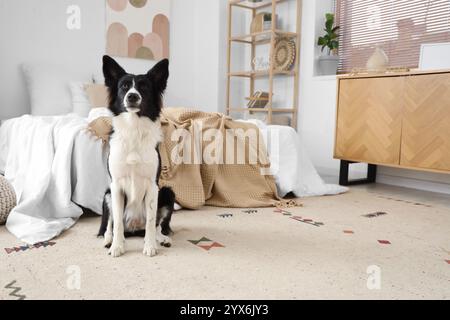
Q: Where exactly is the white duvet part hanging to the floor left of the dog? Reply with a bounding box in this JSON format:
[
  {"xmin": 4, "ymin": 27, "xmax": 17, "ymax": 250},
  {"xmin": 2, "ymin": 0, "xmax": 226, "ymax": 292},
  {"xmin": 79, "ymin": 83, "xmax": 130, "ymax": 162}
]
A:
[{"xmin": 0, "ymin": 115, "xmax": 109, "ymax": 244}]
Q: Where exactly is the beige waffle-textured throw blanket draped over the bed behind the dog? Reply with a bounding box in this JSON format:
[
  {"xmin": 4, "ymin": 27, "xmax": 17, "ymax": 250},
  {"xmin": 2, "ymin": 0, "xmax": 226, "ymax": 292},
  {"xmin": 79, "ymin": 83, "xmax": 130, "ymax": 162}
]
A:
[{"xmin": 90, "ymin": 108, "xmax": 298, "ymax": 209}]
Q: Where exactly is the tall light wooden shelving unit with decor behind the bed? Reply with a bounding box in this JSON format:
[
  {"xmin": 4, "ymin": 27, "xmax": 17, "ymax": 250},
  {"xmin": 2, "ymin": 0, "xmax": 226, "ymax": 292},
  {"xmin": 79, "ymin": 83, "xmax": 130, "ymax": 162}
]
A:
[{"xmin": 227, "ymin": 0, "xmax": 302, "ymax": 128}]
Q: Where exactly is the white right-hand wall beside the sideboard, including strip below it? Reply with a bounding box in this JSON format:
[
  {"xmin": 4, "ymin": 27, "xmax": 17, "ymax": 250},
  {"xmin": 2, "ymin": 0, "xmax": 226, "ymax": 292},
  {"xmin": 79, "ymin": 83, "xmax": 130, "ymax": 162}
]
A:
[{"xmin": 298, "ymin": 0, "xmax": 450, "ymax": 194}]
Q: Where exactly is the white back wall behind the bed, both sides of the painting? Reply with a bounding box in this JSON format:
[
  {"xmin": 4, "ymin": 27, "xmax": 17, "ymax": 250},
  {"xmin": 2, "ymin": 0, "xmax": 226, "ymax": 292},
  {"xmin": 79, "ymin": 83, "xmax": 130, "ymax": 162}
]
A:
[{"xmin": 0, "ymin": 0, "xmax": 221, "ymax": 119}]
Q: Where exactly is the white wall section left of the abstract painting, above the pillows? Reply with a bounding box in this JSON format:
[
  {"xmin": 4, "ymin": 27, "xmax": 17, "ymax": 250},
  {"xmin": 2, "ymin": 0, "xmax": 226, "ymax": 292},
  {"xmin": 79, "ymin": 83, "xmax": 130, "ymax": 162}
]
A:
[{"xmin": 0, "ymin": 0, "xmax": 105, "ymax": 118}]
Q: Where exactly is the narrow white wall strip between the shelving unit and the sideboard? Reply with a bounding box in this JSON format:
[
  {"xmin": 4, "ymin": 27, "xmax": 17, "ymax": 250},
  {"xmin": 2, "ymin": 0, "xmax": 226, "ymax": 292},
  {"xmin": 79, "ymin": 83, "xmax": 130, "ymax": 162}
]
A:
[{"xmin": 298, "ymin": 0, "xmax": 339, "ymax": 174}]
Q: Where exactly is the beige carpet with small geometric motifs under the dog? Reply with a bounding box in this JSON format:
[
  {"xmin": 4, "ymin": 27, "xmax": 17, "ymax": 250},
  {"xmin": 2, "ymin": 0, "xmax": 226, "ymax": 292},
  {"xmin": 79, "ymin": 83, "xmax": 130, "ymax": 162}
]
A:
[{"xmin": 0, "ymin": 187, "xmax": 450, "ymax": 299}]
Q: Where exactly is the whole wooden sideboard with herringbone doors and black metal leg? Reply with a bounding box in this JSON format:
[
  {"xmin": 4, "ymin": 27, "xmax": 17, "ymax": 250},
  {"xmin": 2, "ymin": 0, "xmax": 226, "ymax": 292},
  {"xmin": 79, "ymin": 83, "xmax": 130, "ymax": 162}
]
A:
[{"xmin": 334, "ymin": 70, "xmax": 450, "ymax": 185}]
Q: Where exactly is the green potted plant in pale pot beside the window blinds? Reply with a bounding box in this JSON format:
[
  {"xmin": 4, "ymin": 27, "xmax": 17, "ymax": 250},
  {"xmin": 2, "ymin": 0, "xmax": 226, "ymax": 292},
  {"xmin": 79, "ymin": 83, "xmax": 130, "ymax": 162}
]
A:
[{"xmin": 317, "ymin": 13, "xmax": 339, "ymax": 75}]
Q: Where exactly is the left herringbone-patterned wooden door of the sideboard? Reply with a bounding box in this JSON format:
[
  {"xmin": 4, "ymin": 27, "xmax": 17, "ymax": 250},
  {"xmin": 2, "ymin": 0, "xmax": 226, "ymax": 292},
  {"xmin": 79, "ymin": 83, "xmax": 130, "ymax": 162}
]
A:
[{"xmin": 335, "ymin": 77, "xmax": 405, "ymax": 165}]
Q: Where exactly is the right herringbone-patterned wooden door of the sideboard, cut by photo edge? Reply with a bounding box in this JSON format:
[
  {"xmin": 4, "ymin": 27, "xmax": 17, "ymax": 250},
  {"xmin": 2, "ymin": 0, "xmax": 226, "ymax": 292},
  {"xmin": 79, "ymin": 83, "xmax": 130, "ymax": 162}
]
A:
[{"xmin": 401, "ymin": 73, "xmax": 450, "ymax": 171}]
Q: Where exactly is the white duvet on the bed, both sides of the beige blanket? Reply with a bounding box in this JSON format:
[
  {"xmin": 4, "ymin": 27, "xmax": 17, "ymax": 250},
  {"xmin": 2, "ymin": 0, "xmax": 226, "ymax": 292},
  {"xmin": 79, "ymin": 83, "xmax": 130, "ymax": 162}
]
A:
[{"xmin": 0, "ymin": 114, "xmax": 347, "ymax": 244}]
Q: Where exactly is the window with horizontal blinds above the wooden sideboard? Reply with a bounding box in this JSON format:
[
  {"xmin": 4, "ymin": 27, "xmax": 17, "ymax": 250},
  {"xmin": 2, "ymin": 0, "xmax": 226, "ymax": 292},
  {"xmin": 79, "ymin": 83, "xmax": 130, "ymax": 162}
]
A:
[{"xmin": 336, "ymin": 0, "xmax": 450, "ymax": 73}]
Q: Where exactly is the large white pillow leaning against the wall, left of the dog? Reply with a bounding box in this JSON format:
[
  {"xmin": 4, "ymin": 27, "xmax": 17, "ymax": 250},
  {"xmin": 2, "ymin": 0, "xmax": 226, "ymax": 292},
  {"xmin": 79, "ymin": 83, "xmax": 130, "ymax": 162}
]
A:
[{"xmin": 22, "ymin": 63, "xmax": 90, "ymax": 116}]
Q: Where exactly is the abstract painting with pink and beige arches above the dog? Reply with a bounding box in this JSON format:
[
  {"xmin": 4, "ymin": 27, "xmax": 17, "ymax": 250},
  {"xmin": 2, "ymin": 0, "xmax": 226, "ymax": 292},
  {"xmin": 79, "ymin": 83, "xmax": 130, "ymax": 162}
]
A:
[{"xmin": 106, "ymin": 0, "xmax": 171, "ymax": 60}]
